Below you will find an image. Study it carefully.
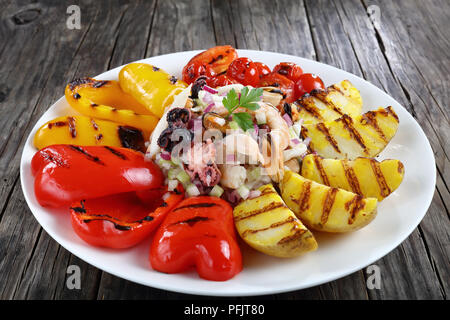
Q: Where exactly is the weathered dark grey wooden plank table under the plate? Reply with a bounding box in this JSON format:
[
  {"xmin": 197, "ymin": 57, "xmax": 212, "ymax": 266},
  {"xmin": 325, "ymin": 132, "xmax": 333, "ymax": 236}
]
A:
[{"xmin": 0, "ymin": 0, "xmax": 450, "ymax": 299}]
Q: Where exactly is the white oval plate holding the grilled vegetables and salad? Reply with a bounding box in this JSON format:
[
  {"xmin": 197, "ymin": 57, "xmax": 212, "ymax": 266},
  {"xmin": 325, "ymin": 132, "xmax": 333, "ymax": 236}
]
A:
[{"xmin": 20, "ymin": 50, "xmax": 436, "ymax": 296}]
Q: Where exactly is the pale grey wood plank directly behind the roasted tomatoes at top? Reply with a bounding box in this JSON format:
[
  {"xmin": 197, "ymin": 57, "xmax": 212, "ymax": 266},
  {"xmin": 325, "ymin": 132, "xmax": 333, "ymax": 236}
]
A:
[{"xmin": 212, "ymin": 0, "xmax": 316, "ymax": 59}]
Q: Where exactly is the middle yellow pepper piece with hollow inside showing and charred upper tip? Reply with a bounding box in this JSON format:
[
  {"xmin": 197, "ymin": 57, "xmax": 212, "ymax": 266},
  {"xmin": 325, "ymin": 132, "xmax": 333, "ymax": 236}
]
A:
[{"xmin": 65, "ymin": 78, "xmax": 159, "ymax": 132}]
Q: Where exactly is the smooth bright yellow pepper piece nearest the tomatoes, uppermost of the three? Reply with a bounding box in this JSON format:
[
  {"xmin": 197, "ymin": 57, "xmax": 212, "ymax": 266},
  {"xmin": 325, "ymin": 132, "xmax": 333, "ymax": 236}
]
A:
[{"xmin": 119, "ymin": 63, "xmax": 187, "ymax": 118}]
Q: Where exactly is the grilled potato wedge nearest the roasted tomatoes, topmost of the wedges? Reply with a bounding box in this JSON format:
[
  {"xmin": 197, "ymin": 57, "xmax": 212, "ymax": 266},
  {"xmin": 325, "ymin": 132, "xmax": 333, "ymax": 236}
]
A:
[{"xmin": 294, "ymin": 80, "xmax": 362, "ymax": 124}]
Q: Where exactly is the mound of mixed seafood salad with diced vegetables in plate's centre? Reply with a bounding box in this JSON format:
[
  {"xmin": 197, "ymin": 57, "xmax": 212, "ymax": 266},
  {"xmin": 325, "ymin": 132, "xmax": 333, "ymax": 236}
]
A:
[{"xmin": 146, "ymin": 78, "xmax": 307, "ymax": 204}]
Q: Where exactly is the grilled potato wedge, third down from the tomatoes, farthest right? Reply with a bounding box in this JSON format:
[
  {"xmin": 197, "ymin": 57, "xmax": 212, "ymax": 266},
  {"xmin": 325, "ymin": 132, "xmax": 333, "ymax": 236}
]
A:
[{"xmin": 301, "ymin": 154, "xmax": 405, "ymax": 201}]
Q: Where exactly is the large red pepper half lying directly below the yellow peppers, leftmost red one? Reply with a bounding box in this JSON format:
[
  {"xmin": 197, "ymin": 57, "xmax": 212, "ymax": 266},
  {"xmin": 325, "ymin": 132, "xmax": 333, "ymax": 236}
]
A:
[{"xmin": 31, "ymin": 145, "xmax": 163, "ymax": 207}]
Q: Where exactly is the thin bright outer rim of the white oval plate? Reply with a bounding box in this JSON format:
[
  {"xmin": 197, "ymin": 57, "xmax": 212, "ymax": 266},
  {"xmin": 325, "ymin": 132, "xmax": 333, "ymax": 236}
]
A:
[{"xmin": 20, "ymin": 49, "xmax": 437, "ymax": 297}]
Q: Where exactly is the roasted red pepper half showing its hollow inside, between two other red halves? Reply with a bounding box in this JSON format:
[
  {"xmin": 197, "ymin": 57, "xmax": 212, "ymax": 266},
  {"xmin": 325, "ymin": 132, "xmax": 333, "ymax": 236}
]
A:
[{"xmin": 70, "ymin": 188, "xmax": 183, "ymax": 249}]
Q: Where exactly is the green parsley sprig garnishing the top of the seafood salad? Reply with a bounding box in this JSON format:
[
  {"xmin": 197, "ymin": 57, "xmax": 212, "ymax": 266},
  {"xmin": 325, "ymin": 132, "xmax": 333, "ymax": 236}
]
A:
[{"xmin": 222, "ymin": 87, "xmax": 263, "ymax": 131}]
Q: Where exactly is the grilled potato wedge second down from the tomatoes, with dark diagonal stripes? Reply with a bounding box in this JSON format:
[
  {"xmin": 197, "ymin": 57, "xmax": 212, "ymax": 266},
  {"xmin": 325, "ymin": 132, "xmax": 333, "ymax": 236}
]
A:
[{"xmin": 301, "ymin": 107, "xmax": 399, "ymax": 160}]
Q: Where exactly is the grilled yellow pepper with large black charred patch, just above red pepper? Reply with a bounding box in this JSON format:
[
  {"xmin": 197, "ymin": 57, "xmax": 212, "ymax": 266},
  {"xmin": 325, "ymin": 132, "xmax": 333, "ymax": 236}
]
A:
[{"xmin": 34, "ymin": 116, "xmax": 150, "ymax": 151}]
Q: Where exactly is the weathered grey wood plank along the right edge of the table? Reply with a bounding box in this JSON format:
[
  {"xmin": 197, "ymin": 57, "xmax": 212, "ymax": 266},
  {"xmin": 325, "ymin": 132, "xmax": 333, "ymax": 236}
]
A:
[{"xmin": 358, "ymin": 1, "xmax": 450, "ymax": 297}]
